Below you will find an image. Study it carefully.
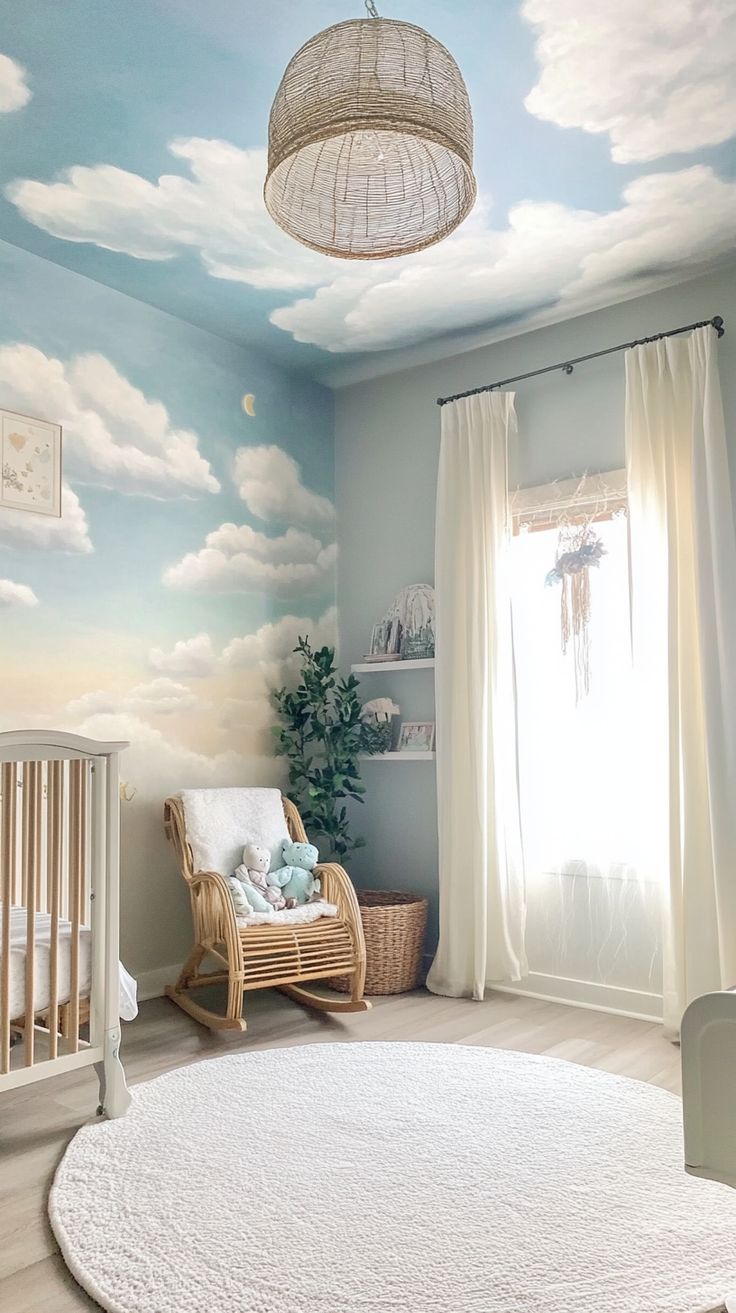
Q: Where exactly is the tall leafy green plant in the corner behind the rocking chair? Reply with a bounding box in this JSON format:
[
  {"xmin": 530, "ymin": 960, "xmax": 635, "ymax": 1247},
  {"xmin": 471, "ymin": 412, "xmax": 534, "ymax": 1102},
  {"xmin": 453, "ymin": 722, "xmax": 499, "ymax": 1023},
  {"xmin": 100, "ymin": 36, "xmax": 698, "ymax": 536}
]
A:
[{"xmin": 272, "ymin": 638, "xmax": 384, "ymax": 861}]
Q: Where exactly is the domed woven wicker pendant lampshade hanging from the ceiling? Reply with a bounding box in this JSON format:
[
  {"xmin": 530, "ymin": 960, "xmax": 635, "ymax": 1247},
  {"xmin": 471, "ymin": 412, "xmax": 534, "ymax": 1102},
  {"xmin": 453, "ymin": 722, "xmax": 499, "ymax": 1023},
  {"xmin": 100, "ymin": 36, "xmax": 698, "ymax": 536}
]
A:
[{"xmin": 264, "ymin": 18, "xmax": 475, "ymax": 260}]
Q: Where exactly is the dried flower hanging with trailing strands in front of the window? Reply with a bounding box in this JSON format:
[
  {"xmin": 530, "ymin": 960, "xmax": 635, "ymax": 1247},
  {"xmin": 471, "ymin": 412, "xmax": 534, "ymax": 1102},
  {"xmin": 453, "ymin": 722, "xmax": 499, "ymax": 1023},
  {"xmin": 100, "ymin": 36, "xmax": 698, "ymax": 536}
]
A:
[{"xmin": 544, "ymin": 521, "xmax": 606, "ymax": 702}]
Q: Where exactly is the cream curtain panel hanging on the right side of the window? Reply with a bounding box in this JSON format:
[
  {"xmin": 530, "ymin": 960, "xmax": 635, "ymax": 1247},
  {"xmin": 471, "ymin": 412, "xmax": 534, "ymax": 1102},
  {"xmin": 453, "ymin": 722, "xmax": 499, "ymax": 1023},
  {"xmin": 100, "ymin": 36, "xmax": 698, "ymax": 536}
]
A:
[{"xmin": 626, "ymin": 328, "xmax": 736, "ymax": 1029}]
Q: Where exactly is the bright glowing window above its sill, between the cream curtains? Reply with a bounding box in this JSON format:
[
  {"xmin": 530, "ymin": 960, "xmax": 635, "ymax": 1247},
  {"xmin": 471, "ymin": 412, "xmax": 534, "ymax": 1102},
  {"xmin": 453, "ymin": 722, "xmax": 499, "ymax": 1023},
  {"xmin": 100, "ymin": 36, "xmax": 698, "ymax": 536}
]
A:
[{"xmin": 512, "ymin": 472, "xmax": 640, "ymax": 880}]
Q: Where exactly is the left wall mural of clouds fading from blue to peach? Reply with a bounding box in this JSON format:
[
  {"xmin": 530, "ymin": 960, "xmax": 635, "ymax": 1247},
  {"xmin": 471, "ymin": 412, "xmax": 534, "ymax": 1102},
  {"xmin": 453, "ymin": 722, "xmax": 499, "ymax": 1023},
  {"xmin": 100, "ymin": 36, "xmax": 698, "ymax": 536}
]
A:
[{"xmin": 0, "ymin": 243, "xmax": 336, "ymax": 970}]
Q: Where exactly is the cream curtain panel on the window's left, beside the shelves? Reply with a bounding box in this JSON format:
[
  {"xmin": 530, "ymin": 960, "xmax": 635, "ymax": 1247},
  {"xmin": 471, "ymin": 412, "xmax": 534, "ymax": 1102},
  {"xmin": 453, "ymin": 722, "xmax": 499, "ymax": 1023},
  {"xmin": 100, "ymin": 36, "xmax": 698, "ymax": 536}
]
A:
[{"xmin": 428, "ymin": 393, "xmax": 527, "ymax": 998}]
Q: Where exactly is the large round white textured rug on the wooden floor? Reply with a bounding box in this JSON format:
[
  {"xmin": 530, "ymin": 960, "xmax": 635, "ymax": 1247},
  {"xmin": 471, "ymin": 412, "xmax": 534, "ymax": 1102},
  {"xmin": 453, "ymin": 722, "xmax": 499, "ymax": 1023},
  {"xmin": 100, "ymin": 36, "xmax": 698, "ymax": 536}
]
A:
[{"xmin": 50, "ymin": 1044, "xmax": 736, "ymax": 1313}]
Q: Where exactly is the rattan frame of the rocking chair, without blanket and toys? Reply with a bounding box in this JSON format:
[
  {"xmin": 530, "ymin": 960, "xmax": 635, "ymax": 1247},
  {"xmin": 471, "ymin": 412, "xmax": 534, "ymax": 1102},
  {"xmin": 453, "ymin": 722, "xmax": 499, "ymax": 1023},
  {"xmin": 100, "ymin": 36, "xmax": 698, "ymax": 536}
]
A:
[{"xmin": 164, "ymin": 797, "xmax": 370, "ymax": 1031}]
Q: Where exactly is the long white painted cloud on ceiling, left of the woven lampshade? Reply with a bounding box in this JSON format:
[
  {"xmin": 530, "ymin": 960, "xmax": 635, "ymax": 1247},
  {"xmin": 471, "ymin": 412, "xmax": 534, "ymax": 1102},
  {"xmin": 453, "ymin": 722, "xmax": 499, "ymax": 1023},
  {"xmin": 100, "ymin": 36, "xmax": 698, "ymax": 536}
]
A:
[{"xmin": 5, "ymin": 137, "xmax": 336, "ymax": 290}]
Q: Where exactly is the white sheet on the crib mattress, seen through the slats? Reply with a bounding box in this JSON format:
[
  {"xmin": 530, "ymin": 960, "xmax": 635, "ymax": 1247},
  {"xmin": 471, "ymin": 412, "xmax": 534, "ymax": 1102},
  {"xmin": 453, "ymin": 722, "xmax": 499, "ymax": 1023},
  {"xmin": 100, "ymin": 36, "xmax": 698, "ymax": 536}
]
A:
[{"xmin": 0, "ymin": 903, "xmax": 138, "ymax": 1022}]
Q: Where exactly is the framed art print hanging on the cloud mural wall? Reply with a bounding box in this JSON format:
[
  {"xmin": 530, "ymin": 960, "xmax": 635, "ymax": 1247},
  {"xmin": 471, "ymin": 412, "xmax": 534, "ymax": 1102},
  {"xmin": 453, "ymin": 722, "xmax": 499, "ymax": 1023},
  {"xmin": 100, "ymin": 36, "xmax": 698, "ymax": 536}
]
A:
[{"xmin": 0, "ymin": 410, "xmax": 62, "ymax": 516}]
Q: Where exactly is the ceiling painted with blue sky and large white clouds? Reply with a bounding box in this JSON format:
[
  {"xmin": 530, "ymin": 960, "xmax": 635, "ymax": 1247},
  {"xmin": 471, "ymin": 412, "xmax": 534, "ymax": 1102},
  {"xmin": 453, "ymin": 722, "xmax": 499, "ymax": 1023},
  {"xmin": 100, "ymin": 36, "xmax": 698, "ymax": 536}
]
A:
[{"xmin": 0, "ymin": 0, "xmax": 736, "ymax": 380}]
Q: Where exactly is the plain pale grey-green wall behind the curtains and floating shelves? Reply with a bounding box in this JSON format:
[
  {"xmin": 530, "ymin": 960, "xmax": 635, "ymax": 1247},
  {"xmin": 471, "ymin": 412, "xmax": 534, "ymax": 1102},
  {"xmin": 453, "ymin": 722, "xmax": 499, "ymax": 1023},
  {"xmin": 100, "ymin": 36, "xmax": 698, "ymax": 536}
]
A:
[{"xmin": 336, "ymin": 268, "xmax": 736, "ymax": 966}]
